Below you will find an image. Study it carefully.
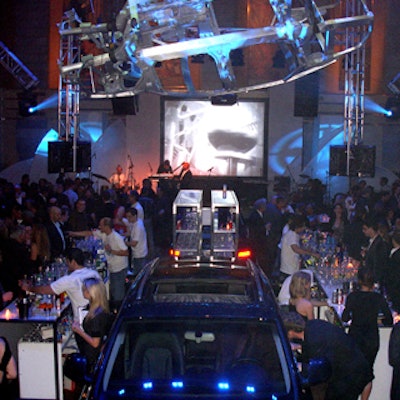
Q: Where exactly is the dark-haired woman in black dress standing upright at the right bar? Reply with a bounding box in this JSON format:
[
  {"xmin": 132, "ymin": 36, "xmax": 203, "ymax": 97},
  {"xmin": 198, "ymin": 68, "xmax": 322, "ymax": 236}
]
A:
[{"xmin": 342, "ymin": 268, "xmax": 393, "ymax": 400}]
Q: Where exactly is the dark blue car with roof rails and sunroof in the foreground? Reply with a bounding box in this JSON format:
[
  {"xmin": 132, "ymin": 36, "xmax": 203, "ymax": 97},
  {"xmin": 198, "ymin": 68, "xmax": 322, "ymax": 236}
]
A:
[{"xmin": 72, "ymin": 255, "xmax": 328, "ymax": 400}]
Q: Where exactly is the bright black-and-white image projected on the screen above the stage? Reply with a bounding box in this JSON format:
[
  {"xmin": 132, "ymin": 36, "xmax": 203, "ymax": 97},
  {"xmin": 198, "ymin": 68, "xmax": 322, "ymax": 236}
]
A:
[{"xmin": 163, "ymin": 100, "xmax": 265, "ymax": 176}]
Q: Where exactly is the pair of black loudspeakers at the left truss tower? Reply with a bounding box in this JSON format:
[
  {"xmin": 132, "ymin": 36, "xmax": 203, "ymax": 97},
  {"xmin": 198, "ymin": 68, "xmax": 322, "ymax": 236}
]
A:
[{"xmin": 47, "ymin": 141, "xmax": 92, "ymax": 174}]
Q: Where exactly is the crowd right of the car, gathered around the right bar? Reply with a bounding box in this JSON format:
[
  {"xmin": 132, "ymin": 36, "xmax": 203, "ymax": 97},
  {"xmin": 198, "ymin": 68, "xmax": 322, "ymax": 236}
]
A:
[{"xmin": 248, "ymin": 178, "xmax": 400, "ymax": 400}]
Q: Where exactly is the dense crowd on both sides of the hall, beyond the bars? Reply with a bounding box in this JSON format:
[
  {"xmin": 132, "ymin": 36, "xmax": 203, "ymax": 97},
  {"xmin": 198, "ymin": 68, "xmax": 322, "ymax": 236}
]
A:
[{"xmin": 0, "ymin": 172, "xmax": 400, "ymax": 309}]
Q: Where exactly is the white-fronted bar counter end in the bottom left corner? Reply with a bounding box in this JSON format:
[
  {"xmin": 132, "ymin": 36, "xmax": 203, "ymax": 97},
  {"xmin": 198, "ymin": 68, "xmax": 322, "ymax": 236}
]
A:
[{"xmin": 0, "ymin": 295, "xmax": 72, "ymax": 400}]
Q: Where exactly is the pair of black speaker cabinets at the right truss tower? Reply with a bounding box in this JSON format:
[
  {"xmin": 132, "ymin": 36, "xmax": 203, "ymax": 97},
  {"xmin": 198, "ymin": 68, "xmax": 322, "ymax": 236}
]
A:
[{"xmin": 329, "ymin": 145, "xmax": 376, "ymax": 177}]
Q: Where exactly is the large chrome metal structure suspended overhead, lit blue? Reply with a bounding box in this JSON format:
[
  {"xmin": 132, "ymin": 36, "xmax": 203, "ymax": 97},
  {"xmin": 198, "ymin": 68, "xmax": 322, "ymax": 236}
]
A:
[{"xmin": 60, "ymin": 0, "xmax": 373, "ymax": 98}]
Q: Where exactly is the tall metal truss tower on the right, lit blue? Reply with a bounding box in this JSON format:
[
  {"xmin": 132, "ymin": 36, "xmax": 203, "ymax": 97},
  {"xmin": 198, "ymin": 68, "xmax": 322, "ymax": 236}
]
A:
[{"xmin": 344, "ymin": 0, "xmax": 368, "ymax": 175}]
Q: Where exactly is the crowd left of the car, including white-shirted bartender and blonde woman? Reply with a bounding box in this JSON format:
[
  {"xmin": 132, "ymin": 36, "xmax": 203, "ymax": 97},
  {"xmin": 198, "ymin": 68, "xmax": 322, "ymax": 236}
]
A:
[{"xmin": 0, "ymin": 170, "xmax": 178, "ymax": 399}]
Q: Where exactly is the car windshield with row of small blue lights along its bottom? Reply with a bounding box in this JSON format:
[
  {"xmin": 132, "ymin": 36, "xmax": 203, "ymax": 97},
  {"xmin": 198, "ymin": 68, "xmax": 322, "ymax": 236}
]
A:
[{"xmin": 101, "ymin": 319, "xmax": 291, "ymax": 399}]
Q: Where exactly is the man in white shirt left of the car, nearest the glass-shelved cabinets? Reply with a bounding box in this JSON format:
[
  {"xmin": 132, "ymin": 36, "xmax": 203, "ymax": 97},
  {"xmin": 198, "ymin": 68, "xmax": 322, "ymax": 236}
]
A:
[{"xmin": 126, "ymin": 207, "xmax": 148, "ymax": 275}]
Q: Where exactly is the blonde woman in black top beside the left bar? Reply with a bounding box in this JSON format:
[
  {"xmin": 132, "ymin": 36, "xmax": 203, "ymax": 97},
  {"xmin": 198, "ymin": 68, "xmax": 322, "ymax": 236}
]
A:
[{"xmin": 72, "ymin": 278, "xmax": 112, "ymax": 373}]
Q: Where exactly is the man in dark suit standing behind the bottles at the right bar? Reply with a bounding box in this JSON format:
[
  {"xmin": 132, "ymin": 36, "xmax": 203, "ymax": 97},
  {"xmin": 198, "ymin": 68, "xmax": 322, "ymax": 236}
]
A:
[{"xmin": 361, "ymin": 218, "xmax": 389, "ymax": 288}]
